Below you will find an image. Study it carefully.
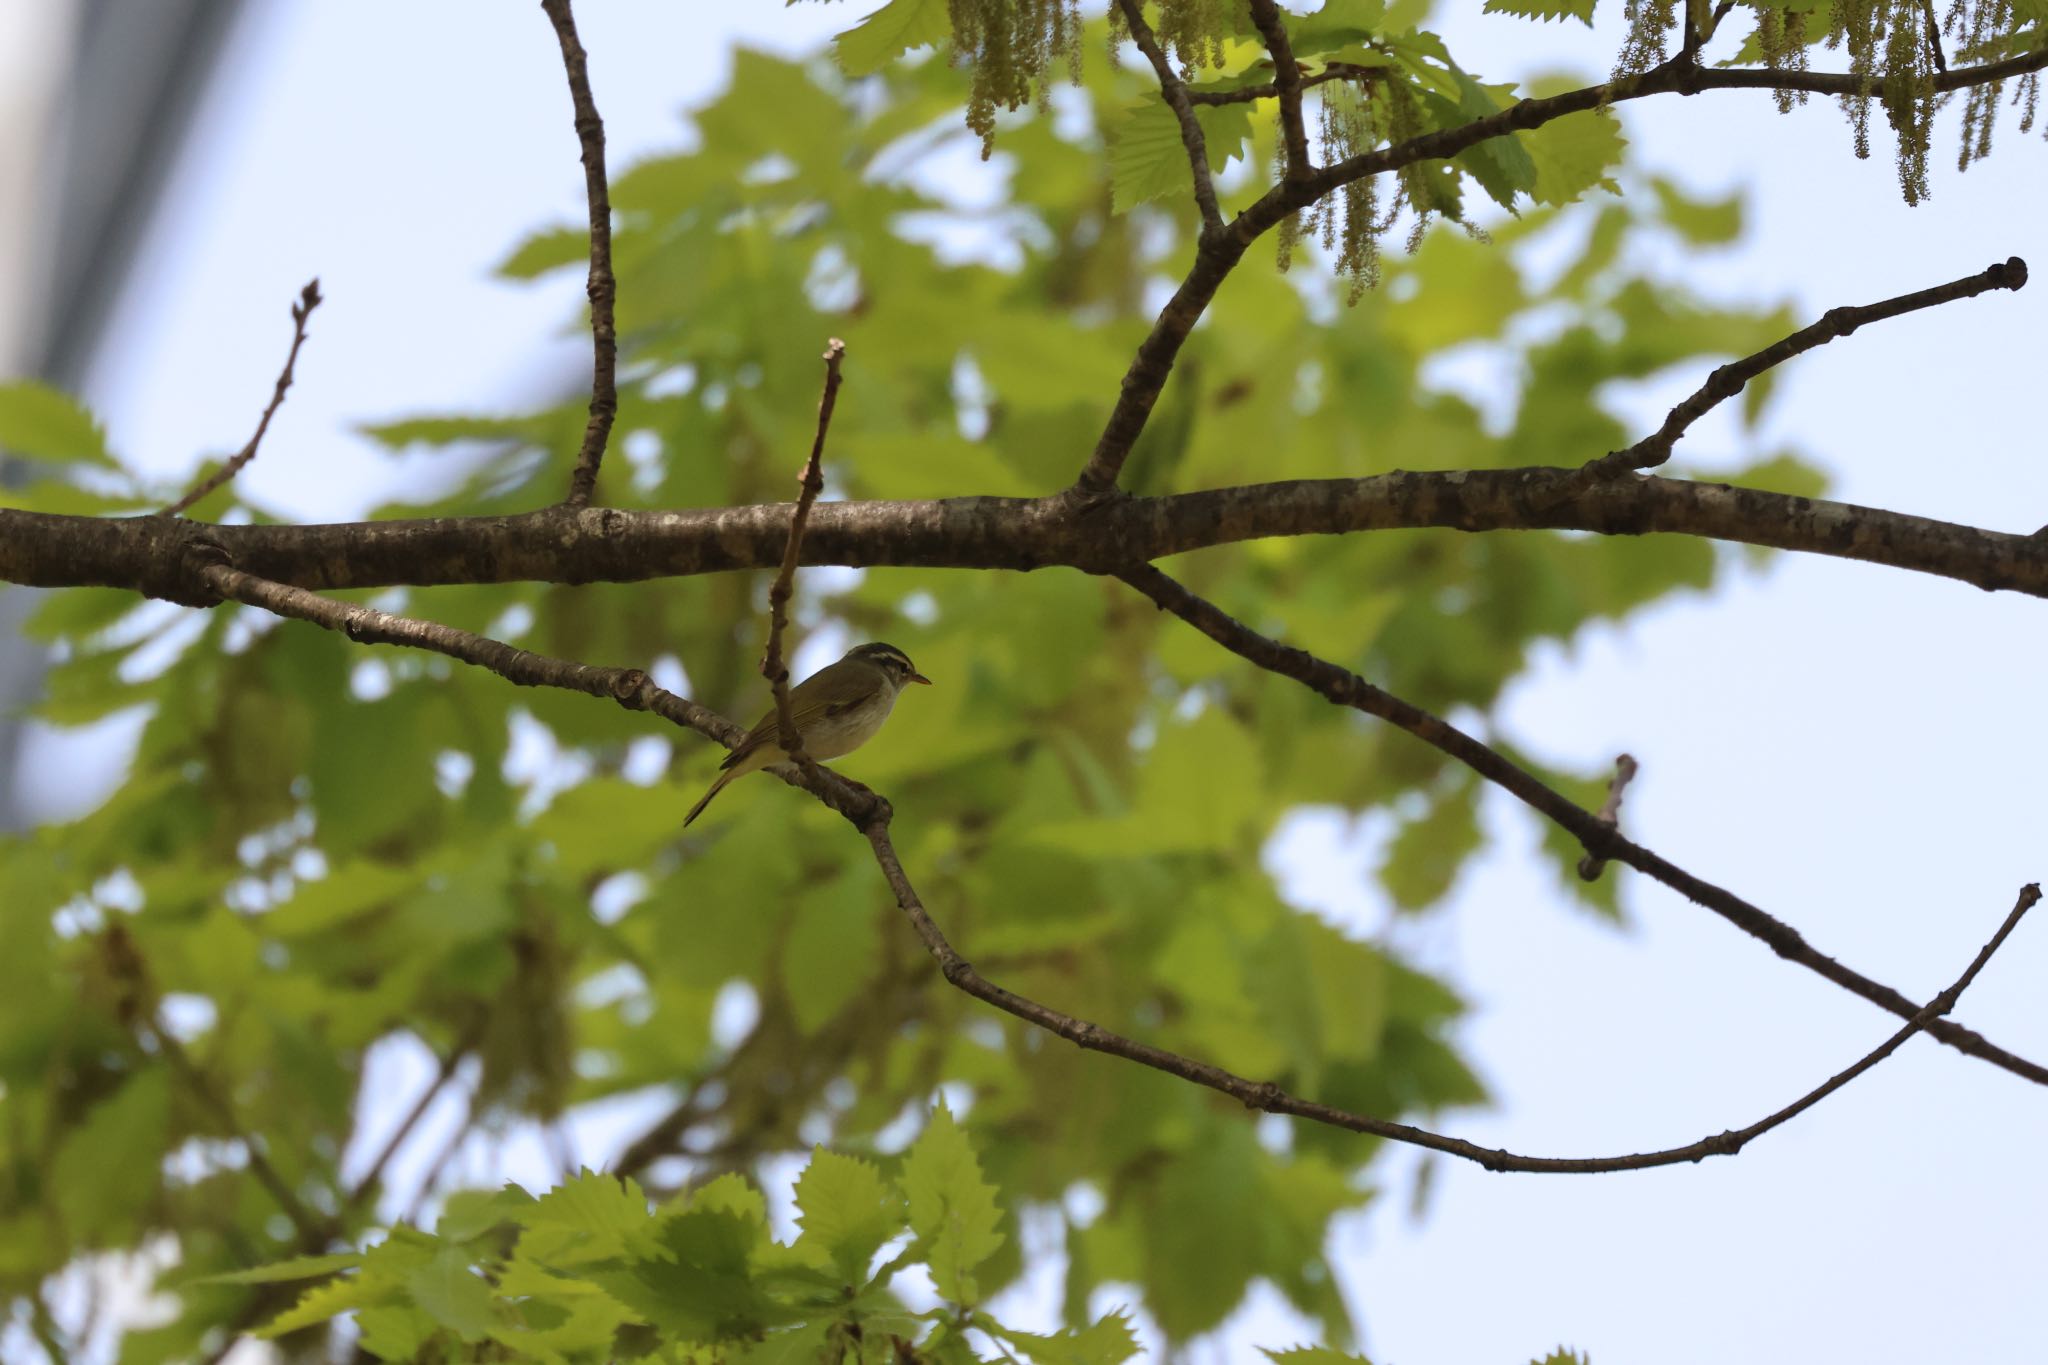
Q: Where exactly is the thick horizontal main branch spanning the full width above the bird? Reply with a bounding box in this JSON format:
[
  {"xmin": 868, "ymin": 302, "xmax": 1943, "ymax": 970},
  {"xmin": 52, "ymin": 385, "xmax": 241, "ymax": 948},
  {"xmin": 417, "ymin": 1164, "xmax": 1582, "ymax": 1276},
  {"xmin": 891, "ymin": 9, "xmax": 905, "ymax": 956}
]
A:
[{"xmin": 0, "ymin": 467, "xmax": 2048, "ymax": 606}]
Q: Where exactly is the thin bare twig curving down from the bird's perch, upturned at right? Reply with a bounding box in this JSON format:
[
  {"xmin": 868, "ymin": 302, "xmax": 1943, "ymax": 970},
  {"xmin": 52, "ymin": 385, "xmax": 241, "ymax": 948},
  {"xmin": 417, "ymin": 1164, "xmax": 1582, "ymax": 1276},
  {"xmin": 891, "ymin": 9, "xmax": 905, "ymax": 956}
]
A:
[{"xmin": 862, "ymin": 814, "xmax": 2040, "ymax": 1175}]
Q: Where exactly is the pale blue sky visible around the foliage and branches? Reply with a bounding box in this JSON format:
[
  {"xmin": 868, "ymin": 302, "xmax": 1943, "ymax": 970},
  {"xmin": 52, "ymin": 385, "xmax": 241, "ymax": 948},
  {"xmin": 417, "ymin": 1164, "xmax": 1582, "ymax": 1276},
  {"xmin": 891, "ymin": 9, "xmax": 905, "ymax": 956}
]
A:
[{"xmin": 44, "ymin": 0, "xmax": 2048, "ymax": 1365}]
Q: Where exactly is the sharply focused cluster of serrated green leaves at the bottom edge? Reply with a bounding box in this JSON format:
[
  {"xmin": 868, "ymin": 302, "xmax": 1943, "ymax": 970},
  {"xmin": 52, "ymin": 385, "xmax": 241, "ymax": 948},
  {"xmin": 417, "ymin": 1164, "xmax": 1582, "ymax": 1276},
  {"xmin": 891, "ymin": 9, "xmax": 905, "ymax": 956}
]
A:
[{"xmin": 211, "ymin": 1105, "xmax": 1137, "ymax": 1365}]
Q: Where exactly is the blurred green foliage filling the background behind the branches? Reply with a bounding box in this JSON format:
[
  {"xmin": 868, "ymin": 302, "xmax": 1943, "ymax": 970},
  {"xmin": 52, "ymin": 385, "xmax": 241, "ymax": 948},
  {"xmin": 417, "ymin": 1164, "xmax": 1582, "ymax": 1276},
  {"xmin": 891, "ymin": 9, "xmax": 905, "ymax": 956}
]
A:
[{"xmin": 0, "ymin": 0, "xmax": 1843, "ymax": 1361}]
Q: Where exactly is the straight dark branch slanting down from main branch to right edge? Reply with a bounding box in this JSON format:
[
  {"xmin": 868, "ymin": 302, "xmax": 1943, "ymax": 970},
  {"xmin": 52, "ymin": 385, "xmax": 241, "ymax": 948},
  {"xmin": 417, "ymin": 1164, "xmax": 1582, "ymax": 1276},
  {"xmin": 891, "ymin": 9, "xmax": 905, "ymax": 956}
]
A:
[{"xmin": 1118, "ymin": 565, "xmax": 2048, "ymax": 1085}]
